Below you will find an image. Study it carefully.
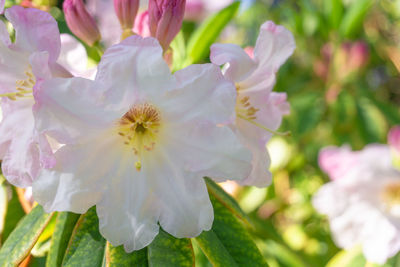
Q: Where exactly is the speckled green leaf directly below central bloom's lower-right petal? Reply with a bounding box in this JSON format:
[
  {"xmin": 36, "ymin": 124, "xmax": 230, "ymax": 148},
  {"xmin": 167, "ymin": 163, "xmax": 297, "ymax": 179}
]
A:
[{"xmin": 147, "ymin": 229, "xmax": 194, "ymax": 267}]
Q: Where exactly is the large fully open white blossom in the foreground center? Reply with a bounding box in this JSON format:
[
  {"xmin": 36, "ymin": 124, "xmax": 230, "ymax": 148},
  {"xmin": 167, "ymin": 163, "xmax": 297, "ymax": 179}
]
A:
[{"xmin": 33, "ymin": 36, "xmax": 251, "ymax": 251}]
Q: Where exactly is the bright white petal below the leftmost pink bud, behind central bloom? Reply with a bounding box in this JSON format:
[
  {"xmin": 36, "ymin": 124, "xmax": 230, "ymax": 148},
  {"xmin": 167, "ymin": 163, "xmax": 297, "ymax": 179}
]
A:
[{"xmin": 57, "ymin": 34, "xmax": 88, "ymax": 78}]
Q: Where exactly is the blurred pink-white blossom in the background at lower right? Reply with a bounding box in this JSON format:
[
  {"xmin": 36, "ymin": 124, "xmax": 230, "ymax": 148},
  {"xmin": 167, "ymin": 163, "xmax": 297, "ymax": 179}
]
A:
[{"xmin": 313, "ymin": 145, "xmax": 400, "ymax": 264}]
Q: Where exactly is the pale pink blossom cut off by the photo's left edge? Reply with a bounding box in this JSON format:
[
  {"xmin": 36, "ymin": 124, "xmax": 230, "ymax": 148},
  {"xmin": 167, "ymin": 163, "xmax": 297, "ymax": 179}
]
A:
[{"xmin": 0, "ymin": 6, "xmax": 65, "ymax": 187}]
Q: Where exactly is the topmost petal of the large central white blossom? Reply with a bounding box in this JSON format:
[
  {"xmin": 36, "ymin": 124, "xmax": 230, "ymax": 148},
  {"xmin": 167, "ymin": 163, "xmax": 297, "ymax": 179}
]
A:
[{"xmin": 96, "ymin": 36, "xmax": 176, "ymax": 109}]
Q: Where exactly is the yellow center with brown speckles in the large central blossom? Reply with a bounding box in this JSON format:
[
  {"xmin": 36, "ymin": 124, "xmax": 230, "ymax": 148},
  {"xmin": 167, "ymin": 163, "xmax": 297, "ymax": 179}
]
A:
[{"xmin": 118, "ymin": 103, "xmax": 161, "ymax": 171}]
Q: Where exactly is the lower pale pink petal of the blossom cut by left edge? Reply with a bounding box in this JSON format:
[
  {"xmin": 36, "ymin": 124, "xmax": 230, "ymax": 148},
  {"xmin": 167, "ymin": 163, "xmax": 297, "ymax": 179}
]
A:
[{"xmin": 0, "ymin": 101, "xmax": 40, "ymax": 187}]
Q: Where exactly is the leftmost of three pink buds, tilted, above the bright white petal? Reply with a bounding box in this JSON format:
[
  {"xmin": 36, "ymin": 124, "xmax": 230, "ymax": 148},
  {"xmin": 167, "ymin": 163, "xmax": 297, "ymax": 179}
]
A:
[{"xmin": 63, "ymin": 0, "xmax": 101, "ymax": 46}]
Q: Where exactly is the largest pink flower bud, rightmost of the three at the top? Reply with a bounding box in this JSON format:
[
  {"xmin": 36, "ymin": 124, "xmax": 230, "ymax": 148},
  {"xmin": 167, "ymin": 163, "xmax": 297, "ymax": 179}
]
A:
[{"xmin": 149, "ymin": 0, "xmax": 186, "ymax": 51}]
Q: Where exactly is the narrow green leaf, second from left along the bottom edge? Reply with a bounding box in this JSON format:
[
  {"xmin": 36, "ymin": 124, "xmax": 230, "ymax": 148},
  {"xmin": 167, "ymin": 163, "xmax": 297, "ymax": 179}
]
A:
[{"xmin": 46, "ymin": 212, "xmax": 80, "ymax": 267}]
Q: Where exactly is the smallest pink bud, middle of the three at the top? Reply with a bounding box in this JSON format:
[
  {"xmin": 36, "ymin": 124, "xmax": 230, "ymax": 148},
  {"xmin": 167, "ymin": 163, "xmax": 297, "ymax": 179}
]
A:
[{"xmin": 114, "ymin": 0, "xmax": 139, "ymax": 30}]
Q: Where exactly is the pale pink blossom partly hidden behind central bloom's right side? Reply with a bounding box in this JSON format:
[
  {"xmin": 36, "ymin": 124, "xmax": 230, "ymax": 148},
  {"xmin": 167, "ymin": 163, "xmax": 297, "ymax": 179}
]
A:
[{"xmin": 210, "ymin": 21, "xmax": 295, "ymax": 187}]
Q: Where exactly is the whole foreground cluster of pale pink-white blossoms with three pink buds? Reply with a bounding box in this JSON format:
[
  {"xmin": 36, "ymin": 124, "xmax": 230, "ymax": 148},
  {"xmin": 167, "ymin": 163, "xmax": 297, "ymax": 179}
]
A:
[{"xmin": 0, "ymin": 0, "xmax": 295, "ymax": 251}]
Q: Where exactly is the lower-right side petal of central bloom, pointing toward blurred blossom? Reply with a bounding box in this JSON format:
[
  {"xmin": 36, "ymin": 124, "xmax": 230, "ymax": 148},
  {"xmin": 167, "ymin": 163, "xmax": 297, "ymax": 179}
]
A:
[{"xmin": 169, "ymin": 121, "xmax": 252, "ymax": 181}]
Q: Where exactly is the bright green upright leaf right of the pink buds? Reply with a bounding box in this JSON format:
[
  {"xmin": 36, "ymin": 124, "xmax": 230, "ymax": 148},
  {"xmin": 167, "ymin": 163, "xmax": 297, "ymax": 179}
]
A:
[{"xmin": 186, "ymin": 2, "xmax": 240, "ymax": 65}]
